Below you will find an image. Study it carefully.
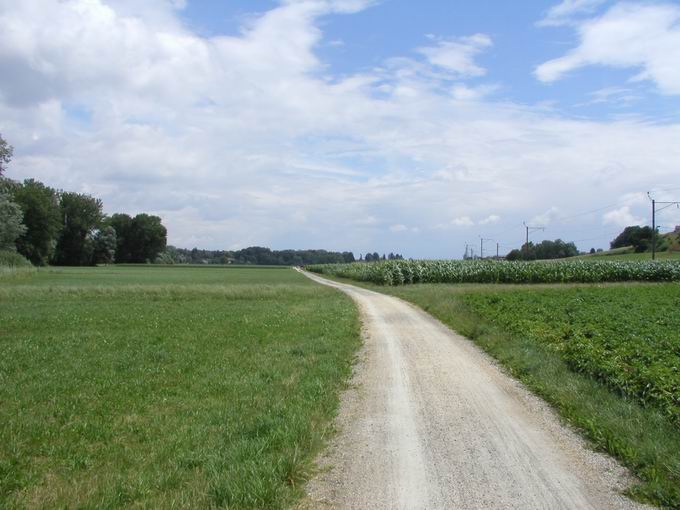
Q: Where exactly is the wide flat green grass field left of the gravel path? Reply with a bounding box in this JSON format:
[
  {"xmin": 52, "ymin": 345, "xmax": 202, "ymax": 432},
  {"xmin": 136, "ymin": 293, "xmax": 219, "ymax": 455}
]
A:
[{"xmin": 0, "ymin": 266, "xmax": 360, "ymax": 509}]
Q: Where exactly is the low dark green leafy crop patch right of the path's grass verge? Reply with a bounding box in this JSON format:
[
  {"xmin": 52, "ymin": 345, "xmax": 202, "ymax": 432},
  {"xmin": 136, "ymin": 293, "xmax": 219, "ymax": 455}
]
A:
[{"xmin": 463, "ymin": 285, "xmax": 680, "ymax": 425}]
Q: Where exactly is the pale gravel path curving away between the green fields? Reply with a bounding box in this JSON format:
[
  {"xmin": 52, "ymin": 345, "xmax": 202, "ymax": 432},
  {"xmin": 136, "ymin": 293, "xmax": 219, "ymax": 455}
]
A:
[{"xmin": 303, "ymin": 273, "xmax": 644, "ymax": 510}]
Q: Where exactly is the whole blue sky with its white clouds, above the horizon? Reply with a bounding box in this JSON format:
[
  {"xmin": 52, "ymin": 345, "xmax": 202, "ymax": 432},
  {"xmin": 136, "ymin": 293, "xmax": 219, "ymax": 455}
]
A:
[{"xmin": 0, "ymin": 0, "xmax": 680, "ymax": 258}]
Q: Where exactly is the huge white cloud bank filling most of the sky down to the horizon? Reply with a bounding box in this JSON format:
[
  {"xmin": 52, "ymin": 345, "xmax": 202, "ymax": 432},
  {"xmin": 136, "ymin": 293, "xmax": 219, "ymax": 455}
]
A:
[{"xmin": 0, "ymin": 0, "xmax": 680, "ymax": 257}]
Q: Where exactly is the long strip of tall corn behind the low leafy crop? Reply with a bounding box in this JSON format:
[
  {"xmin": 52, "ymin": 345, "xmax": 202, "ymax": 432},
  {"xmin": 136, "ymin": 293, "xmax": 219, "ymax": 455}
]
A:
[{"xmin": 307, "ymin": 260, "xmax": 680, "ymax": 285}]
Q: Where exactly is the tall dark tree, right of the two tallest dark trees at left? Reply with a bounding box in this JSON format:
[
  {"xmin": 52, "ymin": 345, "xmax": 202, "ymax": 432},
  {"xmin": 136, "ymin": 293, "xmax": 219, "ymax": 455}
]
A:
[{"xmin": 54, "ymin": 192, "xmax": 103, "ymax": 266}]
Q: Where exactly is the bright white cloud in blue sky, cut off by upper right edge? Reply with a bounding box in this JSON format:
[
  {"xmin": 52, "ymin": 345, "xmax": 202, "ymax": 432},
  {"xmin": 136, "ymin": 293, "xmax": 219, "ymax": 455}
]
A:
[{"xmin": 535, "ymin": 3, "xmax": 680, "ymax": 94}]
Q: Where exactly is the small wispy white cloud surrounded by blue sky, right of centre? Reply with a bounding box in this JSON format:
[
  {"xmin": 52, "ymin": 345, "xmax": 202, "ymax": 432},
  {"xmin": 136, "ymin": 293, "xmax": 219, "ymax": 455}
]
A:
[{"xmin": 418, "ymin": 34, "xmax": 493, "ymax": 77}]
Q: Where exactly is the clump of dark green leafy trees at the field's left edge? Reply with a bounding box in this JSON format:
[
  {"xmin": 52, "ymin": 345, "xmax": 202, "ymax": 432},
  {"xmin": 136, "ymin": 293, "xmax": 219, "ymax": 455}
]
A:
[{"xmin": 0, "ymin": 132, "xmax": 167, "ymax": 266}]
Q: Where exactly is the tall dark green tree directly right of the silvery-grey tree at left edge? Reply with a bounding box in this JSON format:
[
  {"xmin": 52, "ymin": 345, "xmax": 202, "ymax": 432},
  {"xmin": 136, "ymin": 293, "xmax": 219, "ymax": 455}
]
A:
[{"xmin": 14, "ymin": 179, "xmax": 62, "ymax": 265}]
